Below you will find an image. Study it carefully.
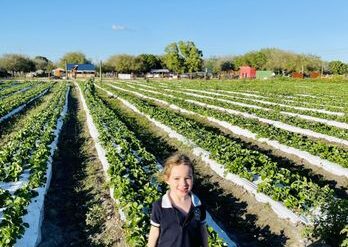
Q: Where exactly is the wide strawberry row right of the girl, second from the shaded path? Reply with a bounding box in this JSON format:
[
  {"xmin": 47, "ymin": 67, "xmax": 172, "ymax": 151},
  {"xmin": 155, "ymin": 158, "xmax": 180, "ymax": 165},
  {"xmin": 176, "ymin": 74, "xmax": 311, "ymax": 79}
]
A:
[{"xmin": 94, "ymin": 83, "xmax": 332, "ymax": 216}]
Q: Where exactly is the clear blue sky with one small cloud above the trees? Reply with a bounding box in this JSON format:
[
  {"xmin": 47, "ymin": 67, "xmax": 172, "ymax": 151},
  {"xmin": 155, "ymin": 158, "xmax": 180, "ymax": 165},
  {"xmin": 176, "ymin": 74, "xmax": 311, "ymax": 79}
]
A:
[{"xmin": 0, "ymin": 0, "xmax": 348, "ymax": 63}]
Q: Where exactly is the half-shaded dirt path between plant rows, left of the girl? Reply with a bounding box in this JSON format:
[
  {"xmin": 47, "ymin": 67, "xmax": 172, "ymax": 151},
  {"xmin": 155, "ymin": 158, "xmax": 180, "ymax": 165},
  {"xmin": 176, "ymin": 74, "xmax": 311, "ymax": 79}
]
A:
[{"xmin": 39, "ymin": 85, "xmax": 126, "ymax": 247}]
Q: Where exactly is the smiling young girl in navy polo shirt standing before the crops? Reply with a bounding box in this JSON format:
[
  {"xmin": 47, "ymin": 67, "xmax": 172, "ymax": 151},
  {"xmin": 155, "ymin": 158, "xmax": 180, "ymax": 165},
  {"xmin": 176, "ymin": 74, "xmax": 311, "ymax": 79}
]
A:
[{"xmin": 148, "ymin": 154, "xmax": 208, "ymax": 247}]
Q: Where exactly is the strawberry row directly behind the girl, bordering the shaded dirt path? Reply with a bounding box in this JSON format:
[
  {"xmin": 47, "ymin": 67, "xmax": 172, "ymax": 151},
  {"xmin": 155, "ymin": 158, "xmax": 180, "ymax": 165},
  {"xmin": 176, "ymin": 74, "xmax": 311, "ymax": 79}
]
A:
[{"xmin": 80, "ymin": 84, "xmax": 230, "ymax": 246}]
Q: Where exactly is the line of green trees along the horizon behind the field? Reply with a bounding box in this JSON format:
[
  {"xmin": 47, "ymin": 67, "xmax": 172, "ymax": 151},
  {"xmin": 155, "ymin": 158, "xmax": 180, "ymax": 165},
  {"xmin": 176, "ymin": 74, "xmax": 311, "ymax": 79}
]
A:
[{"xmin": 0, "ymin": 41, "xmax": 348, "ymax": 75}]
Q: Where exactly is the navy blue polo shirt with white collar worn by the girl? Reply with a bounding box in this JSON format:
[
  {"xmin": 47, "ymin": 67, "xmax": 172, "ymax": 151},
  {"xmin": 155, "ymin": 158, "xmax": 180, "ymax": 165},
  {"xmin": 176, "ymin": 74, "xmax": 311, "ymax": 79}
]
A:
[{"xmin": 151, "ymin": 192, "xmax": 206, "ymax": 247}]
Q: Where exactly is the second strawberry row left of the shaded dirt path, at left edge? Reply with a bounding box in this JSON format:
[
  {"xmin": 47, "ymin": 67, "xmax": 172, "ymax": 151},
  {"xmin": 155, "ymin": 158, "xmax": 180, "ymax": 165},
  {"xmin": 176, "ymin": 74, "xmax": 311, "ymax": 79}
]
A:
[{"xmin": 0, "ymin": 83, "xmax": 51, "ymax": 117}]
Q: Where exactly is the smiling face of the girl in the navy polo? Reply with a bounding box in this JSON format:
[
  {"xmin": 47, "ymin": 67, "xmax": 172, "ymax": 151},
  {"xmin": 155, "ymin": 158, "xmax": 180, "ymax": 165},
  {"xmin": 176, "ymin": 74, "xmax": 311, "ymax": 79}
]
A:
[{"xmin": 166, "ymin": 165, "xmax": 193, "ymax": 198}]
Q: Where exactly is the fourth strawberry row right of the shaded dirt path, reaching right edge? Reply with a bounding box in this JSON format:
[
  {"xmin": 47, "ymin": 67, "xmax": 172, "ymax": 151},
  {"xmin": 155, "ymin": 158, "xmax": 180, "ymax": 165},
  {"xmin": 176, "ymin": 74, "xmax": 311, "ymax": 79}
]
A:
[{"xmin": 117, "ymin": 81, "xmax": 348, "ymax": 140}]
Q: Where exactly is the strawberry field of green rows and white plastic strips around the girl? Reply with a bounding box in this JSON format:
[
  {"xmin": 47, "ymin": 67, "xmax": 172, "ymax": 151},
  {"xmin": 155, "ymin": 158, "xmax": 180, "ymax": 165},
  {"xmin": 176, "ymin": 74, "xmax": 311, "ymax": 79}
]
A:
[{"xmin": 0, "ymin": 80, "xmax": 348, "ymax": 246}]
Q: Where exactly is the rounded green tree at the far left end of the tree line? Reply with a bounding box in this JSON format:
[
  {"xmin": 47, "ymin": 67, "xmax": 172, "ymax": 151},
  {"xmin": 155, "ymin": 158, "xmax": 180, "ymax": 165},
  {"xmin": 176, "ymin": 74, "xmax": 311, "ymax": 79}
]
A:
[{"xmin": 0, "ymin": 54, "xmax": 35, "ymax": 75}]
